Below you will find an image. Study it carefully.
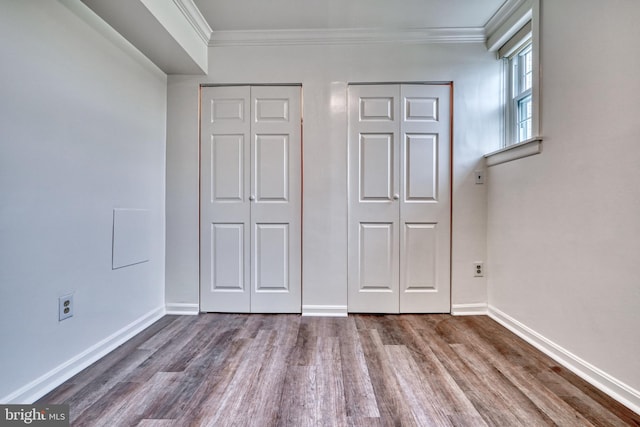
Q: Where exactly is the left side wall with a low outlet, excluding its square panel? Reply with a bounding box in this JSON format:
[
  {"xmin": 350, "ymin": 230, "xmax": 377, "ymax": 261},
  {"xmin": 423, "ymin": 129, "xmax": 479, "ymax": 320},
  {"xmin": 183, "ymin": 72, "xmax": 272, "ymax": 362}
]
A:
[{"xmin": 0, "ymin": 0, "xmax": 166, "ymax": 403}]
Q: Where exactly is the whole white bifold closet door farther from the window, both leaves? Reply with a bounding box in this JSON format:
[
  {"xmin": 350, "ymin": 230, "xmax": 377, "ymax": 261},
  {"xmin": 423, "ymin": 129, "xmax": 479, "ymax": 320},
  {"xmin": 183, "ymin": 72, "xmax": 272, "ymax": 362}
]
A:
[{"xmin": 200, "ymin": 86, "xmax": 301, "ymax": 313}]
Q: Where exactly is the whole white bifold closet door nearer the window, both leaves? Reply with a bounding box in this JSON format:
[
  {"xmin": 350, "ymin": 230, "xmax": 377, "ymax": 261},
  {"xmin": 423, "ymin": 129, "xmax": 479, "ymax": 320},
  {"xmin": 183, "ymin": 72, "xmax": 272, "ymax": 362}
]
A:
[{"xmin": 348, "ymin": 85, "xmax": 451, "ymax": 313}]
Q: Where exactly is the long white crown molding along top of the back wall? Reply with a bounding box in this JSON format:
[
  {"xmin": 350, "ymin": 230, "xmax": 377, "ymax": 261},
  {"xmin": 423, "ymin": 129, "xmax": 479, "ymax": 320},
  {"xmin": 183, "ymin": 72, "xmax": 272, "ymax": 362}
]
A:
[{"xmin": 209, "ymin": 27, "xmax": 486, "ymax": 47}]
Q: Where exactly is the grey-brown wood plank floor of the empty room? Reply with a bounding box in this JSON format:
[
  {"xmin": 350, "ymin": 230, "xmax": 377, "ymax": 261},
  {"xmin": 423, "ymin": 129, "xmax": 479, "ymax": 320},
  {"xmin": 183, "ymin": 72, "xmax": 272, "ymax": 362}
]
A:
[{"xmin": 40, "ymin": 314, "xmax": 640, "ymax": 427}]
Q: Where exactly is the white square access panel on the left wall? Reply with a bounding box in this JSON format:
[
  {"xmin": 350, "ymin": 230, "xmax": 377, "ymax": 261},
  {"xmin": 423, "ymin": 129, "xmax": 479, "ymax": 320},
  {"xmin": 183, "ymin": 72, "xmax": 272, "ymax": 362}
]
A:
[{"xmin": 111, "ymin": 209, "xmax": 151, "ymax": 270}]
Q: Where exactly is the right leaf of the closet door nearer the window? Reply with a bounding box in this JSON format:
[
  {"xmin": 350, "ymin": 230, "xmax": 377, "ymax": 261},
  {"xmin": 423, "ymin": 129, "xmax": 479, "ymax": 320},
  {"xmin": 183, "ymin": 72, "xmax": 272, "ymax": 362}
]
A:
[{"xmin": 400, "ymin": 85, "xmax": 451, "ymax": 313}]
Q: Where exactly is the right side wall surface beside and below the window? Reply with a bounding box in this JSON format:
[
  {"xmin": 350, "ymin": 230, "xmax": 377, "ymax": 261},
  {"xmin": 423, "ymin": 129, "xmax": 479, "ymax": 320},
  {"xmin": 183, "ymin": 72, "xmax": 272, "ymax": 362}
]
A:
[{"xmin": 487, "ymin": 0, "xmax": 640, "ymax": 400}]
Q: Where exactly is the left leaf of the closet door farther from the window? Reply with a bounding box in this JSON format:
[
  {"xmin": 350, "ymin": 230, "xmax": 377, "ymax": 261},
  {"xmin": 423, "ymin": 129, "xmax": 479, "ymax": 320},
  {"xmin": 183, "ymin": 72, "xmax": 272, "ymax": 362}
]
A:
[{"xmin": 200, "ymin": 86, "xmax": 251, "ymax": 313}]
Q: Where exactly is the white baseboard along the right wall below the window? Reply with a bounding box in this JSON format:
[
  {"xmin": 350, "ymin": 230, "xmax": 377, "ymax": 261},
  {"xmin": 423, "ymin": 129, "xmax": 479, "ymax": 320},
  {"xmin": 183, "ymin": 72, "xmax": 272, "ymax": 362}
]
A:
[{"xmin": 489, "ymin": 306, "xmax": 640, "ymax": 414}]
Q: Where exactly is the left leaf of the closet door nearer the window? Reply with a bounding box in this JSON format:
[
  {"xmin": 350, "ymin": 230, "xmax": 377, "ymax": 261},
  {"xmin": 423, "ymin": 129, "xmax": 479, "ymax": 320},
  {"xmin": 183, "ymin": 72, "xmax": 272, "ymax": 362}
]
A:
[{"xmin": 348, "ymin": 85, "xmax": 400, "ymax": 313}]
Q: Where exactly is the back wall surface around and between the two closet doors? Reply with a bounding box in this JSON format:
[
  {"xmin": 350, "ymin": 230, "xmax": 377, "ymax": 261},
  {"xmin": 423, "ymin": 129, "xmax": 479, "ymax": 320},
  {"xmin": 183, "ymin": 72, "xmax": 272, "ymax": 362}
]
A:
[{"xmin": 166, "ymin": 44, "xmax": 499, "ymax": 312}]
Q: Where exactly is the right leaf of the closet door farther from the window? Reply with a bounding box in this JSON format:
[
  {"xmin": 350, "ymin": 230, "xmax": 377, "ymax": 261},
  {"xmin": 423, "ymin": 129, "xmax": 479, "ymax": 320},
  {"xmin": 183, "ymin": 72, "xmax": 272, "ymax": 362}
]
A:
[{"xmin": 250, "ymin": 86, "xmax": 302, "ymax": 313}]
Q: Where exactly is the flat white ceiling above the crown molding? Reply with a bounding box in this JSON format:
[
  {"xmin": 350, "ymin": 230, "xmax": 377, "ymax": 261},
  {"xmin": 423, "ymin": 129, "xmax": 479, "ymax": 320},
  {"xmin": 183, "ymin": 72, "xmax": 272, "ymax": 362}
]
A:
[{"xmin": 194, "ymin": 0, "xmax": 505, "ymax": 31}]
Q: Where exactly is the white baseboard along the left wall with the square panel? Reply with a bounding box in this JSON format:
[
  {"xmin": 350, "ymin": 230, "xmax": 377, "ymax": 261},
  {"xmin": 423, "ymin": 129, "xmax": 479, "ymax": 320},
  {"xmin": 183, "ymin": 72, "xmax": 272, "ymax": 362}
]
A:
[{"xmin": 0, "ymin": 307, "xmax": 165, "ymax": 404}]
